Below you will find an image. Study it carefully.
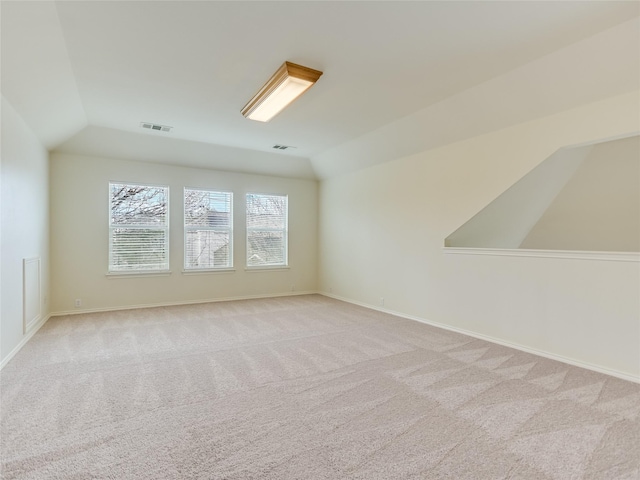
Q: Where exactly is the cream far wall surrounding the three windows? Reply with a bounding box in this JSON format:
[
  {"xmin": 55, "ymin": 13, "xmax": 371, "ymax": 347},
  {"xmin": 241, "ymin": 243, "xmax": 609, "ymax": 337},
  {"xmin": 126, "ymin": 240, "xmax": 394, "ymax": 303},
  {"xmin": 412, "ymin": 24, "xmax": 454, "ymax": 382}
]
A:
[{"xmin": 51, "ymin": 153, "xmax": 318, "ymax": 312}]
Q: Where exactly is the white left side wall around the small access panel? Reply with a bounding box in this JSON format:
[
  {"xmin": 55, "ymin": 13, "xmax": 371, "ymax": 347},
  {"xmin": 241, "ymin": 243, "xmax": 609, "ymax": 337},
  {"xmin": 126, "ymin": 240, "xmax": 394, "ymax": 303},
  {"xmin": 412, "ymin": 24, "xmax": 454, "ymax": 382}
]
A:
[{"xmin": 0, "ymin": 97, "xmax": 49, "ymax": 364}]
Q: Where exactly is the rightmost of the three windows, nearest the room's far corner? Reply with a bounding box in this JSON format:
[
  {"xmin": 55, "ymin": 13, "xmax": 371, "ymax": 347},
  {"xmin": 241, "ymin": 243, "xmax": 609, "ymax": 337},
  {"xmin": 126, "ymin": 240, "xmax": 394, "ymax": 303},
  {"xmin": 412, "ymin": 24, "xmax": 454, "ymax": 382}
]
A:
[{"xmin": 247, "ymin": 193, "xmax": 287, "ymax": 267}]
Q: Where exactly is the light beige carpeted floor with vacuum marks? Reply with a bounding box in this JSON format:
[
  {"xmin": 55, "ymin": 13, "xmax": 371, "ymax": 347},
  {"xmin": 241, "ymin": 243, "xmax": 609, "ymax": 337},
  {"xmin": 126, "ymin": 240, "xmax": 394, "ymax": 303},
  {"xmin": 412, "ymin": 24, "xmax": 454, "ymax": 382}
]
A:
[{"xmin": 0, "ymin": 295, "xmax": 640, "ymax": 480}]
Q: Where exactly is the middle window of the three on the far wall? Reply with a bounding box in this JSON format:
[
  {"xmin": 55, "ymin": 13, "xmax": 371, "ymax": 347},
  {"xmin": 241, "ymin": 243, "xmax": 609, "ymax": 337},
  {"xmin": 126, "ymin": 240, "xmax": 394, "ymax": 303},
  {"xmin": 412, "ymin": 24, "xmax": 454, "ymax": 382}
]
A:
[{"xmin": 184, "ymin": 188, "xmax": 233, "ymax": 270}]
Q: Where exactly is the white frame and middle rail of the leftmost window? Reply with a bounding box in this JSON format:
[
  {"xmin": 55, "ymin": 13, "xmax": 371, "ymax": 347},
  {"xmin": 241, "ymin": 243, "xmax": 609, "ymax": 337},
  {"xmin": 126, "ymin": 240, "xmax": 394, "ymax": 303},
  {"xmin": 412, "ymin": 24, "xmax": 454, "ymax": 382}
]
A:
[{"xmin": 108, "ymin": 181, "xmax": 170, "ymax": 275}]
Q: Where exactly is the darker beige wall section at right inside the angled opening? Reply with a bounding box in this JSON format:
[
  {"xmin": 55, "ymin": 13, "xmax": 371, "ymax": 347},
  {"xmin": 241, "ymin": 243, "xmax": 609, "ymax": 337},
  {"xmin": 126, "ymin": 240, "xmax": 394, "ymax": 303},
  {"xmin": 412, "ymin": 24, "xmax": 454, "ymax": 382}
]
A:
[{"xmin": 520, "ymin": 136, "xmax": 640, "ymax": 252}]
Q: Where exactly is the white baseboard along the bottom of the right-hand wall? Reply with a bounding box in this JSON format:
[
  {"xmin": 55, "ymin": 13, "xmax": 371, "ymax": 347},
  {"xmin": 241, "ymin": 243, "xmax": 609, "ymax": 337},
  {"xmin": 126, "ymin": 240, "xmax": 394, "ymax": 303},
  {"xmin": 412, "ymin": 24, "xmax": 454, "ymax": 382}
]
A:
[{"xmin": 318, "ymin": 292, "xmax": 640, "ymax": 383}]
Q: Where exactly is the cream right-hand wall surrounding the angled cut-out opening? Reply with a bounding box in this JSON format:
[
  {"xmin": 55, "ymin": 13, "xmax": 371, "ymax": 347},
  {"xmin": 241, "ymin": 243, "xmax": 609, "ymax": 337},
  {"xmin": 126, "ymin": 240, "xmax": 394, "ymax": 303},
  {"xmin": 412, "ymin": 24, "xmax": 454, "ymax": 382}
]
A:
[{"xmin": 319, "ymin": 92, "xmax": 640, "ymax": 379}]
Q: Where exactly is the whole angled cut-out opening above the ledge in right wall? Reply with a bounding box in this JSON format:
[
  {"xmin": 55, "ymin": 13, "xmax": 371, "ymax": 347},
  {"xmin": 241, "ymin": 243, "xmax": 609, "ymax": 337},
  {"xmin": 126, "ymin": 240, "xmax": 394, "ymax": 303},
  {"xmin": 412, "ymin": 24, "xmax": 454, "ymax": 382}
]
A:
[{"xmin": 445, "ymin": 135, "xmax": 640, "ymax": 252}]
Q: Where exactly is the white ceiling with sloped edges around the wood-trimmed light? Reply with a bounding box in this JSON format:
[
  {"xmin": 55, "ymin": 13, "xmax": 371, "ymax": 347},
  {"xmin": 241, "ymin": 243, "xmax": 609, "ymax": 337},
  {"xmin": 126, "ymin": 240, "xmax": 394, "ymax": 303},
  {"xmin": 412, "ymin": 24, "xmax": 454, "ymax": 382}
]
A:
[{"xmin": 1, "ymin": 0, "xmax": 640, "ymax": 178}]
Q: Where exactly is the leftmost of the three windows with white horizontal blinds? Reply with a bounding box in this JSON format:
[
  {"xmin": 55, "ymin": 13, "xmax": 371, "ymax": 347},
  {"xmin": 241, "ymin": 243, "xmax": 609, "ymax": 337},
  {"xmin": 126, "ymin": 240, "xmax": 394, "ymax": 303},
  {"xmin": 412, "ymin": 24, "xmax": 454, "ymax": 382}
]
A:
[{"xmin": 109, "ymin": 183, "xmax": 169, "ymax": 272}]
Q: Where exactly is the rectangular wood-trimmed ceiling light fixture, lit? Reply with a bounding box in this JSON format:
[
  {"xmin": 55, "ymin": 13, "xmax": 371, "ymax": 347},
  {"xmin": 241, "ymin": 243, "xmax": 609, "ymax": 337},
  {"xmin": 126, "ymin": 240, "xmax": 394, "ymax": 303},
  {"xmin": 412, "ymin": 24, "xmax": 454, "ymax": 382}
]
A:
[{"xmin": 242, "ymin": 62, "xmax": 322, "ymax": 122}]
